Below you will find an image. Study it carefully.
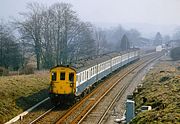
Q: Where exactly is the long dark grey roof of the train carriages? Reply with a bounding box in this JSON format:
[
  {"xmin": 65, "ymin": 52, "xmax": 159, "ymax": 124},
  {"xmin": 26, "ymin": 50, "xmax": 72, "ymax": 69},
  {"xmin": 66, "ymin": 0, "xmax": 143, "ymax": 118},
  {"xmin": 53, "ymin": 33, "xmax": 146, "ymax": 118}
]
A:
[{"xmin": 73, "ymin": 48, "xmax": 138, "ymax": 73}]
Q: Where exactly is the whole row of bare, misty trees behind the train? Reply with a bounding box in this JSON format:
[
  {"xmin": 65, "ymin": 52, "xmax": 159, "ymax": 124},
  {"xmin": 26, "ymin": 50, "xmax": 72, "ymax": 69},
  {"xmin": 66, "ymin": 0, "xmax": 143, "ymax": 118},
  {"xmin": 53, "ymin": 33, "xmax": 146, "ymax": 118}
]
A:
[{"xmin": 0, "ymin": 3, "xmax": 143, "ymax": 70}]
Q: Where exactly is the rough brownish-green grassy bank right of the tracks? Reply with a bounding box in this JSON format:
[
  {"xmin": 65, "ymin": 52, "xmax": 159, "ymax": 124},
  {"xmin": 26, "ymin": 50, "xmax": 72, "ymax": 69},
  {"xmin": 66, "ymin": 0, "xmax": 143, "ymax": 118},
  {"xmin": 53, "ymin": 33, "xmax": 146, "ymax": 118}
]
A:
[{"xmin": 132, "ymin": 58, "xmax": 180, "ymax": 124}]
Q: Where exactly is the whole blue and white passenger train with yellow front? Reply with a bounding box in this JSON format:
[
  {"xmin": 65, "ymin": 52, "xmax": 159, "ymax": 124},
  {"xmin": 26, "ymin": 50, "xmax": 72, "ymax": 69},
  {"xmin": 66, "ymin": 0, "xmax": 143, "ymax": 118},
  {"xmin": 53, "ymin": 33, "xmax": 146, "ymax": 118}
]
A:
[{"xmin": 49, "ymin": 48, "xmax": 140, "ymax": 104}]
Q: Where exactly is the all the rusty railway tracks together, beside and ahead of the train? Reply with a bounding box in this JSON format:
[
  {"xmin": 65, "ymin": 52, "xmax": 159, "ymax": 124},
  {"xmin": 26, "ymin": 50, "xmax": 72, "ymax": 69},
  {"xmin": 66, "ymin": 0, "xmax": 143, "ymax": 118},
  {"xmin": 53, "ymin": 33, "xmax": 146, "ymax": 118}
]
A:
[{"xmin": 26, "ymin": 51, "xmax": 164, "ymax": 124}]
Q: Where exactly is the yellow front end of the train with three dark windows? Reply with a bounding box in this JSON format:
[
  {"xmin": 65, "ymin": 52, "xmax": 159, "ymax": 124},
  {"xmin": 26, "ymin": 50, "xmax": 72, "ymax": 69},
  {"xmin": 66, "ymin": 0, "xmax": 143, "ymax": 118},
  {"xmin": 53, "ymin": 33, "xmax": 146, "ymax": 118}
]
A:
[{"xmin": 49, "ymin": 66, "xmax": 76, "ymax": 104}]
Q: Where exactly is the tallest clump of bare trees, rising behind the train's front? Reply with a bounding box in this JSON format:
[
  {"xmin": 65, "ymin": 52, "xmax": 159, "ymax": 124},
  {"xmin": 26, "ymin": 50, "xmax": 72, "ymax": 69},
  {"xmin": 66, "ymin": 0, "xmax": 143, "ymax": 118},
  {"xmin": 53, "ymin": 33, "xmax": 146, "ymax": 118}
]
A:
[{"xmin": 16, "ymin": 3, "xmax": 97, "ymax": 69}]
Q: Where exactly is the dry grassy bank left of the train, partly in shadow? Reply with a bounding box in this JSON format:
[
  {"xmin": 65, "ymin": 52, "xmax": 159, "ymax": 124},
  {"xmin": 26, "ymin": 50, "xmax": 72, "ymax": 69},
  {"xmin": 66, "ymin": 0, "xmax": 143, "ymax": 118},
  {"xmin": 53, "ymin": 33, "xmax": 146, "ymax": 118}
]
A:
[{"xmin": 0, "ymin": 71, "xmax": 49, "ymax": 123}]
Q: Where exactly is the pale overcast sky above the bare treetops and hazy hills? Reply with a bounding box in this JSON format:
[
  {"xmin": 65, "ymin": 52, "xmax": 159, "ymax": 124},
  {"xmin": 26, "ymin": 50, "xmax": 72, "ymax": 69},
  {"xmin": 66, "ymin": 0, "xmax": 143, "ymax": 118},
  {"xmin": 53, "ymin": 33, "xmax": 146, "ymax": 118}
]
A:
[{"xmin": 0, "ymin": 0, "xmax": 180, "ymax": 36}]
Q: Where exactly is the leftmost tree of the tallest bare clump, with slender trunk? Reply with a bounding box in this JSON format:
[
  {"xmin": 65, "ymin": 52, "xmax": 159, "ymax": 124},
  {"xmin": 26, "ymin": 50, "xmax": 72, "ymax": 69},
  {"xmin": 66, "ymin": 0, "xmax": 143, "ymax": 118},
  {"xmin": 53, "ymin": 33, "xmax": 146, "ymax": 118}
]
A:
[{"xmin": 16, "ymin": 3, "xmax": 43, "ymax": 70}]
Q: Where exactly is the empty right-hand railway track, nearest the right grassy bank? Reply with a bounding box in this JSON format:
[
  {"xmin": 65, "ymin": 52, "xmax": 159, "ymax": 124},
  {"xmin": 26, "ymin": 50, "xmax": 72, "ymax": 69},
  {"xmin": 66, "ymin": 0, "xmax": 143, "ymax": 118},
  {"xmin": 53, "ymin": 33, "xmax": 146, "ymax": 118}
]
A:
[{"xmin": 77, "ymin": 52, "xmax": 162, "ymax": 124}]
